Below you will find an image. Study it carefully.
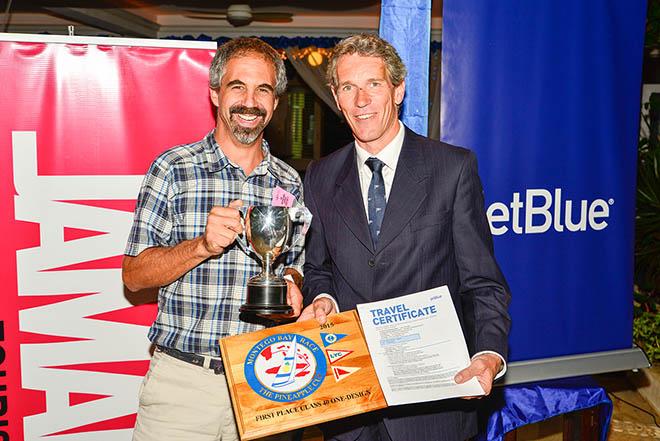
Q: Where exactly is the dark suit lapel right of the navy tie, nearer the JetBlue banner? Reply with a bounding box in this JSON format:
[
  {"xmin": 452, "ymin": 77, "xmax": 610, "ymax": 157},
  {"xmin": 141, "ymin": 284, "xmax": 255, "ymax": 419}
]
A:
[{"xmin": 376, "ymin": 129, "xmax": 427, "ymax": 251}]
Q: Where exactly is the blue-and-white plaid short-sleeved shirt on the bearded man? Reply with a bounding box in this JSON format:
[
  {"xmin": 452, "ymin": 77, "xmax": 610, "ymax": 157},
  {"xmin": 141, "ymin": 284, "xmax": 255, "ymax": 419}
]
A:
[{"xmin": 125, "ymin": 131, "xmax": 304, "ymax": 356}]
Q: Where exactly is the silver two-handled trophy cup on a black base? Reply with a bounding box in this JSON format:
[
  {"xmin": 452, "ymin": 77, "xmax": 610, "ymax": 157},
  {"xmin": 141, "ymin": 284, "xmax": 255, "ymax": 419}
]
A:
[{"xmin": 240, "ymin": 205, "xmax": 293, "ymax": 316}]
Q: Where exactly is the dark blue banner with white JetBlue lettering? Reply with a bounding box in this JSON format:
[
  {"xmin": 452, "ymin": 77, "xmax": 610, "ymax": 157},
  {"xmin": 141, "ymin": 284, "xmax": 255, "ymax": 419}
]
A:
[{"xmin": 441, "ymin": 0, "xmax": 646, "ymax": 360}]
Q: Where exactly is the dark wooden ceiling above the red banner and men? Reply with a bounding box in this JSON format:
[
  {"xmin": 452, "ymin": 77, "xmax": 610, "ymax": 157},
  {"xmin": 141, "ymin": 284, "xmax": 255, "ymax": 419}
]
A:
[{"xmin": 0, "ymin": 0, "xmax": 442, "ymax": 39}]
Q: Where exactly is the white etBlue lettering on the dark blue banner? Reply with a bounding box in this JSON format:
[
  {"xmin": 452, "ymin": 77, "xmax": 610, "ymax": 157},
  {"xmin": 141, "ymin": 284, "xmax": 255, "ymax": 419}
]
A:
[{"xmin": 486, "ymin": 188, "xmax": 614, "ymax": 236}]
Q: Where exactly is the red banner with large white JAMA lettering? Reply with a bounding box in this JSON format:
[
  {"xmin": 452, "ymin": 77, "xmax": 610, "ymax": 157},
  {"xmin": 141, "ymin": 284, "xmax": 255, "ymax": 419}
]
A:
[{"xmin": 0, "ymin": 36, "xmax": 214, "ymax": 441}]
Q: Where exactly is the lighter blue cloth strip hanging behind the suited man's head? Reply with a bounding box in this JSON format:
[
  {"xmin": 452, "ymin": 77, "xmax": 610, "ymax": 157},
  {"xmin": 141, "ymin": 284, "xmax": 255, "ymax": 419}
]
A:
[{"xmin": 380, "ymin": 0, "xmax": 431, "ymax": 135}]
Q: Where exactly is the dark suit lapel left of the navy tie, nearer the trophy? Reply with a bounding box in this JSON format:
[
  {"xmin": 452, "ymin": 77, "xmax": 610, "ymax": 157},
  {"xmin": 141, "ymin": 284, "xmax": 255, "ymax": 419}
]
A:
[{"xmin": 333, "ymin": 148, "xmax": 374, "ymax": 252}]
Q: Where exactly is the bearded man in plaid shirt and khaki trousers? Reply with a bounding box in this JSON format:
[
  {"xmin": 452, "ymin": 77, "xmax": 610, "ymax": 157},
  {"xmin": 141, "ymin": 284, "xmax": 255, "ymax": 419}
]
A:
[{"xmin": 122, "ymin": 38, "xmax": 303, "ymax": 441}]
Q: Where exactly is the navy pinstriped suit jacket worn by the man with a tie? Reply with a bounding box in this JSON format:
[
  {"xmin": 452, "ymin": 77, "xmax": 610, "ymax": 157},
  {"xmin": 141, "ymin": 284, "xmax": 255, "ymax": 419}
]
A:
[{"xmin": 303, "ymin": 128, "xmax": 510, "ymax": 441}]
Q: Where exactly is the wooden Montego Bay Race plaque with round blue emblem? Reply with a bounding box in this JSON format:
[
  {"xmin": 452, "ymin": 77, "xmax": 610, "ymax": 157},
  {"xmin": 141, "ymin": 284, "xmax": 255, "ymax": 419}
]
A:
[{"xmin": 220, "ymin": 310, "xmax": 387, "ymax": 440}]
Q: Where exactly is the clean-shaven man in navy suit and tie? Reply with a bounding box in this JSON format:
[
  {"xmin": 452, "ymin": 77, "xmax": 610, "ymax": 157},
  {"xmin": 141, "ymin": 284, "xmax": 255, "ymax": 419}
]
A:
[{"xmin": 300, "ymin": 35, "xmax": 510, "ymax": 441}]
